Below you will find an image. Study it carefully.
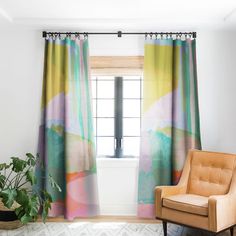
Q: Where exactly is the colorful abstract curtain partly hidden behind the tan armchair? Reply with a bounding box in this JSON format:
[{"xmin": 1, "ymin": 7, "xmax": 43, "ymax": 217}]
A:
[{"xmin": 138, "ymin": 39, "xmax": 201, "ymax": 217}]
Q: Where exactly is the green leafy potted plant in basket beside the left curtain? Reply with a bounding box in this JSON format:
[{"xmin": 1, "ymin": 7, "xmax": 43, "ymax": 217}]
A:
[{"xmin": 0, "ymin": 153, "xmax": 61, "ymax": 229}]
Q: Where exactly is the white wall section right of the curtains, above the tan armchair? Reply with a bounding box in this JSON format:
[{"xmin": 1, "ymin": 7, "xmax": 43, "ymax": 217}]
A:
[{"xmin": 197, "ymin": 31, "xmax": 236, "ymax": 153}]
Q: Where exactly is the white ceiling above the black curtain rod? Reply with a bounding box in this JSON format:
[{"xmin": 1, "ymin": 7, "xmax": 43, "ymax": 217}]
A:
[{"xmin": 0, "ymin": 0, "xmax": 236, "ymax": 31}]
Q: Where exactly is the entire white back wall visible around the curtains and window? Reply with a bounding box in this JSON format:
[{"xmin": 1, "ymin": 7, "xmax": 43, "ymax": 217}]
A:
[{"xmin": 0, "ymin": 30, "xmax": 236, "ymax": 215}]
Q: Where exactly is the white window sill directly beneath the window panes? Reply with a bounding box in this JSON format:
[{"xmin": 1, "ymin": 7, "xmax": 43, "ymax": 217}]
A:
[{"xmin": 96, "ymin": 157, "xmax": 139, "ymax": 168}]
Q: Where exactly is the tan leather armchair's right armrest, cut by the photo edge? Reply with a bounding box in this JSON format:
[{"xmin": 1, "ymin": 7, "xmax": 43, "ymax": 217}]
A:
[{"xmin": 208, "ymin": 193, "xmax": 236, "ymax": 232}]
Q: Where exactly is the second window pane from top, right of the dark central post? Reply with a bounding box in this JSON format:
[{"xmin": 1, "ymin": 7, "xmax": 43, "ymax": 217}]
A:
[{"xmin": 123, "ymin": 99, "xmax": 140, "ymax": 117}]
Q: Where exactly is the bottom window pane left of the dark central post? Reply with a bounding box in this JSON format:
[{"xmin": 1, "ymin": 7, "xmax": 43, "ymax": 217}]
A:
[{"xmin": 97, "ymin": 137, "xmax": 114, "ymax": 156}]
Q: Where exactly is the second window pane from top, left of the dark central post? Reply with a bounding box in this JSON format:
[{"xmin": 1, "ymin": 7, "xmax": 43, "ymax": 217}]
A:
[{"xmin": 97, "ymin": 99, "xmax": 114, "ymax": 117}]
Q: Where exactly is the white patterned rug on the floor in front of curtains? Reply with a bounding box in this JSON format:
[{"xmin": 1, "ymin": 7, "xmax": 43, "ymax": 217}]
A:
[{"xmin": 0, "ymin": 222, "xmax": 182, "ymax": 236}]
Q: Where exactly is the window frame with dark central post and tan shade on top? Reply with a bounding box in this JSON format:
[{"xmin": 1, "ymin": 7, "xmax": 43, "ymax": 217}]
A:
[{"xmin": 90, "ymin": 56, "xmax": 143, "ymax": 158}]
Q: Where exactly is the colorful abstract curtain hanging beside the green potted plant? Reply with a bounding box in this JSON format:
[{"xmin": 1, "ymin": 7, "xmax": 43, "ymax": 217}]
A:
[{"xmin": 37, "ymin": 38, "xmax": 98, "ymax": 219}]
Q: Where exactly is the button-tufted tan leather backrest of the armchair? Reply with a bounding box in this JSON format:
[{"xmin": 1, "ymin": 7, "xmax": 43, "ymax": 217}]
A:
[{"xmin": 187, "ymin": 150, "xmax": 236, "ymax": 197}]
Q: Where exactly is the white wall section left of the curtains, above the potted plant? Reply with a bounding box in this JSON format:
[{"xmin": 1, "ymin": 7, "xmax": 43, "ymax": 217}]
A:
[{"xmin": 0, "ymin": 30, "xmax": 44, "ymax": 161}]
